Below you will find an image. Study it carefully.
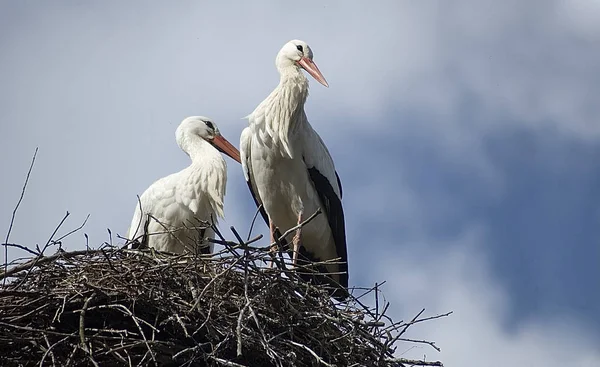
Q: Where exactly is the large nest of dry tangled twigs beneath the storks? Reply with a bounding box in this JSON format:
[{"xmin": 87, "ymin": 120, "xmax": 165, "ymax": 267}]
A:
[{"xmin": 0, "ymin": 224, "xmax": 444, "ymax": 366}]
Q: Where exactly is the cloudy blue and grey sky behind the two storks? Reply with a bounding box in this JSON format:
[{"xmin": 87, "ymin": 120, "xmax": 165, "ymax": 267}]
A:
[{"xmin": 0, "ymin": 0, "xmax": 600, "ymax": 366}]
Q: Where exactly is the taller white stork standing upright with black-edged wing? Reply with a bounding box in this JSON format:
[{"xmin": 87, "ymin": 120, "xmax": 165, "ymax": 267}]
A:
[{"xmin": 240, "ymin": 40, "xmax": 348, "ymax": 299}]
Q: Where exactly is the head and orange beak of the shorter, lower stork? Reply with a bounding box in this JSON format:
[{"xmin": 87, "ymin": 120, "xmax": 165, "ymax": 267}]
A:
[{"xmin": 175, "ymin": 116, "xmax": 241, "ymax": 163}]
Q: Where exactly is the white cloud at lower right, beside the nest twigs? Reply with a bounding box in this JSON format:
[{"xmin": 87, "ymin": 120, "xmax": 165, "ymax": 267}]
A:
[{"xmin": 372, "ymin": 227, "xmax": 600, "ymax": 367}]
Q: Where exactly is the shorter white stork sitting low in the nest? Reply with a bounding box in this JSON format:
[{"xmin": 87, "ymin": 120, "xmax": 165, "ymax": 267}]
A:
[{"xmin": 127, "ymin": 116, "xmax": 240, "ymax": 253}]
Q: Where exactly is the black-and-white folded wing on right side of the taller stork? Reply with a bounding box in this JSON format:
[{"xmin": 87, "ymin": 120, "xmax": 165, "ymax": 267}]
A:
[{"xmin": 303, "ymin": 125, "xmax": 348, "ymax": 288}]
